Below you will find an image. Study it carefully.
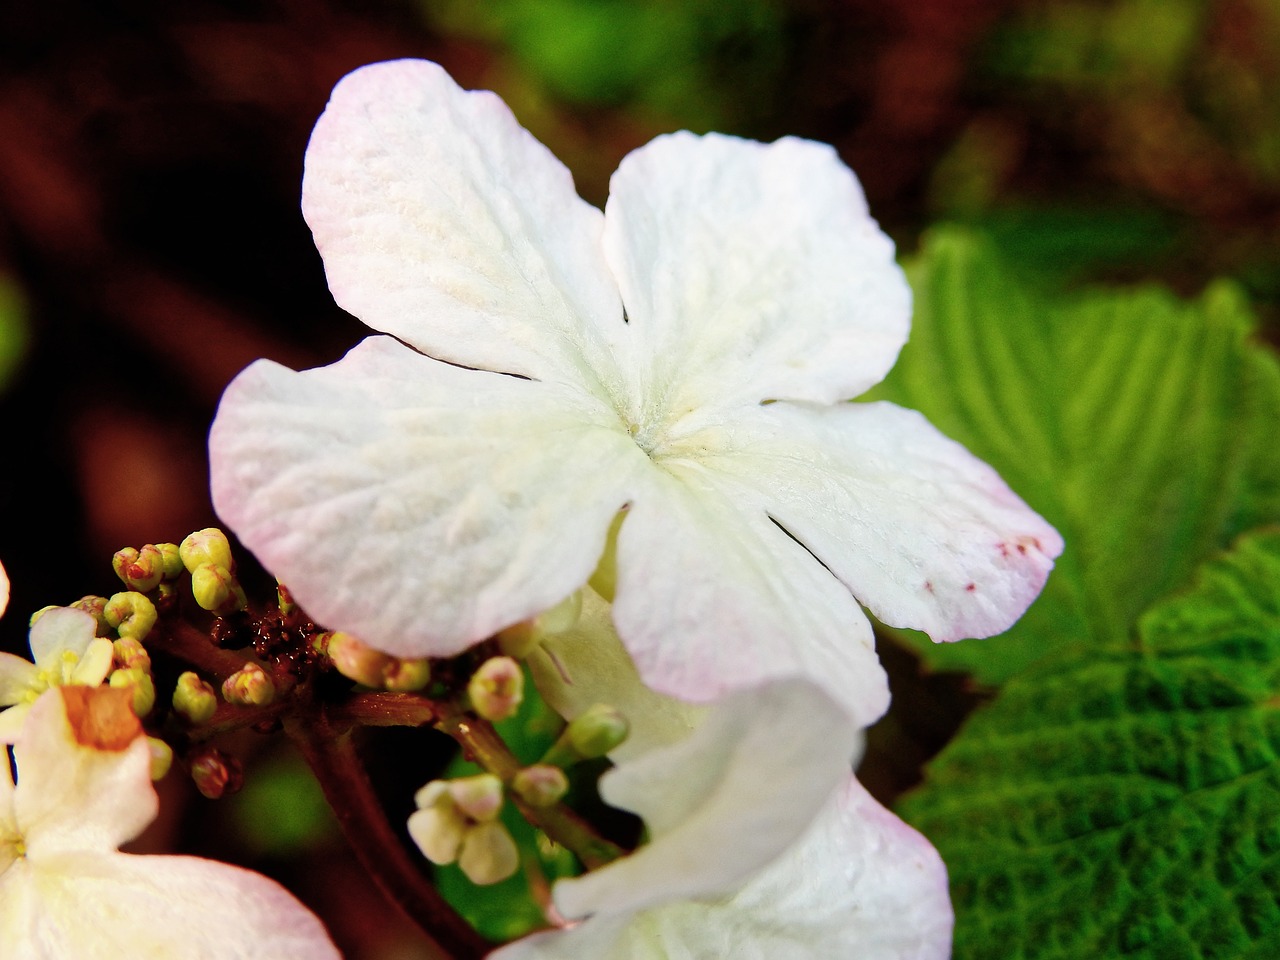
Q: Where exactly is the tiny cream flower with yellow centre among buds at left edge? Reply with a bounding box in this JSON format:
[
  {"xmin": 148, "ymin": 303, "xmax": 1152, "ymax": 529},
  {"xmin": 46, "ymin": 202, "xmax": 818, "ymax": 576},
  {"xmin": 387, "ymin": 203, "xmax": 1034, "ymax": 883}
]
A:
[{"xmin": 0, "ymin": 607, "xmax": 111, "ymax": 744}]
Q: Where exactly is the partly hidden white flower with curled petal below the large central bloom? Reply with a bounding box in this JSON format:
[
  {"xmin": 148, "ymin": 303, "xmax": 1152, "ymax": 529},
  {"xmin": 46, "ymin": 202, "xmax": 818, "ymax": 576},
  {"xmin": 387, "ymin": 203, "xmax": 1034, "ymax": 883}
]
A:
[{"xmin": 493, "ymin": 596, "xmax": 952, "ymax": 960}]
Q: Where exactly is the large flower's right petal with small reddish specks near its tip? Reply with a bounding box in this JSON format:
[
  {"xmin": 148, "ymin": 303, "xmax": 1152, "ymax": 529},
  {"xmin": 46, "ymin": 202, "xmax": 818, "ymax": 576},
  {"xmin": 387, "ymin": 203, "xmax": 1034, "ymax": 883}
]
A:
[{"xmin": 686, "ymin": 403, "xmax": 1062, "ymax": 641}]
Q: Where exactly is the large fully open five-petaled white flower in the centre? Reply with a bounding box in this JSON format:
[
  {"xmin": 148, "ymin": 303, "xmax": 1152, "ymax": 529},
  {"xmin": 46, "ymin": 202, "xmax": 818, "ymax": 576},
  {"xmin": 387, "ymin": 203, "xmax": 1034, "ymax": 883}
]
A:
[{"xmin": 210, "ymin": 60, "xmax": 1061, "ymax": 723}]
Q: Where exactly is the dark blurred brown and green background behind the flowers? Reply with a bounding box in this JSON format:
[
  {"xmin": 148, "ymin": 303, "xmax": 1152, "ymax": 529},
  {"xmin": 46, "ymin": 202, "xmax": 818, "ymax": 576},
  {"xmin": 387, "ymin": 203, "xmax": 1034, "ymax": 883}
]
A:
[{"xmin": 0, "ymin": 0, "xmax": 1280, "ymax": 959}]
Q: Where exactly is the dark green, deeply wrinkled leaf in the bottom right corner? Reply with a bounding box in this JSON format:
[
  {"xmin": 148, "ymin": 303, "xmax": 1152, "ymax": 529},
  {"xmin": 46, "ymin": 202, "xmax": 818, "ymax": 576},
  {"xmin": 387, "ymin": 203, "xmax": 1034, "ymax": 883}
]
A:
[{"xmin": 902, "ymin": 529, "xmax": 1280, "ymax": 960}]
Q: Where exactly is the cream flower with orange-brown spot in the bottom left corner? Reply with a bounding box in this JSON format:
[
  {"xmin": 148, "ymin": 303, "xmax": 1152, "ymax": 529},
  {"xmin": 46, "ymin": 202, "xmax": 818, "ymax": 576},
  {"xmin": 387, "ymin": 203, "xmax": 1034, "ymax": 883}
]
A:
[{"xmin": 0, "ymin": 687, "xmax": 339, "ymax": 960}]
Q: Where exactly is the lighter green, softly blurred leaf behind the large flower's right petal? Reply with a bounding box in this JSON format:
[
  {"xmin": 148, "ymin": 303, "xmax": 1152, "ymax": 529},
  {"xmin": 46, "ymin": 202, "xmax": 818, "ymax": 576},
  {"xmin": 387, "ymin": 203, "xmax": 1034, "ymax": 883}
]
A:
[{"xmin": 870, "ymin": 229, "xmax": 1280, "ymax": 684}]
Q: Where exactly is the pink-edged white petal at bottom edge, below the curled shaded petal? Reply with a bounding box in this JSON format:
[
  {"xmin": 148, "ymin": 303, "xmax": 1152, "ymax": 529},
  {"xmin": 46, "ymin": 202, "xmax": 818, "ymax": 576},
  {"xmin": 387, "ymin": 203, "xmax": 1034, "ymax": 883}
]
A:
[{"xmin": 493, "ymin": 780, "xmax": 952, "ymax": 960}]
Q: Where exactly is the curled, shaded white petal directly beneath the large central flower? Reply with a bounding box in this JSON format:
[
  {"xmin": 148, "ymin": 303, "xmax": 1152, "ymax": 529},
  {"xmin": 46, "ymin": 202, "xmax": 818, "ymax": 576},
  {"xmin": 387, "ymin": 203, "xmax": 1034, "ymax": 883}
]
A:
[{"xmin": 554, "ymin": 681, "xmax": 854, "ymax": 916}]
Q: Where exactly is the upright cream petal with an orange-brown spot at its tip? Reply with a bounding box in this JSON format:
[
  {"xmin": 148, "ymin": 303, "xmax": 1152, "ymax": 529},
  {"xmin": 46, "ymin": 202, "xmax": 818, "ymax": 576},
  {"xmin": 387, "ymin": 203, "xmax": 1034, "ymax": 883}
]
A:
[{"xmin": 13, "ymin": 687, "xmax": 159, "ymax": 858}]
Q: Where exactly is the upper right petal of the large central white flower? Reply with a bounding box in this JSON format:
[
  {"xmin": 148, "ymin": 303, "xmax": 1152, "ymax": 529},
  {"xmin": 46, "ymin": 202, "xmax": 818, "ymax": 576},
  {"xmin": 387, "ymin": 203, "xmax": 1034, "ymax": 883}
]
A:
[{"xmin": 604, "ymin": 133, "xmax": 911, "ymax": 417}]
